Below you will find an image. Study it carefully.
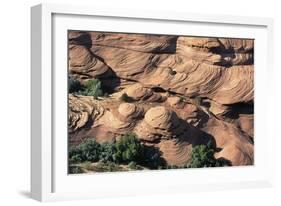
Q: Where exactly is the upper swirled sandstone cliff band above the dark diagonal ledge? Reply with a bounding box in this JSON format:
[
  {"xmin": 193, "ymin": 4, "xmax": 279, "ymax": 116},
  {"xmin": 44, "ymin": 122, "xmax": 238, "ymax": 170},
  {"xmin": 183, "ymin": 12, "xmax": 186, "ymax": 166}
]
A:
[{"xmin": 70, "ymin": 32, "xmax": 253, "ymax": 104}]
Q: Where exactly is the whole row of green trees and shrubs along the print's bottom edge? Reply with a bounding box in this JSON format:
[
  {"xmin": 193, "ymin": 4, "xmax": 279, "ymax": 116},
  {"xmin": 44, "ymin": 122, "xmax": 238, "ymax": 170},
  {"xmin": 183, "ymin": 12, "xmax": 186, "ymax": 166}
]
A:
[{"xmin": 69, "ymin": 133, "xmax": 231, "ymax": 171}]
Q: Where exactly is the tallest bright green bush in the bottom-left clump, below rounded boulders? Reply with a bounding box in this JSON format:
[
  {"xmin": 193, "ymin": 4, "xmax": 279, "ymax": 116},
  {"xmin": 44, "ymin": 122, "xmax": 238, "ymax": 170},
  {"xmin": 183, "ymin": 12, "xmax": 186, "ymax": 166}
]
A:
[{"xmin": 114, "ymin": 133, "xmax": 143, "ymax": 163}]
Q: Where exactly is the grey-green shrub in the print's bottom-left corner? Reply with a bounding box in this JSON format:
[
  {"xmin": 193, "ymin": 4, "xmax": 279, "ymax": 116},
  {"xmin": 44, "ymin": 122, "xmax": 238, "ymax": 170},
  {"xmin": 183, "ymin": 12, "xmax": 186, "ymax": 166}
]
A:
[{"xmin": 69, "ymin": 139, "xmax": 101, "ymax": 163}]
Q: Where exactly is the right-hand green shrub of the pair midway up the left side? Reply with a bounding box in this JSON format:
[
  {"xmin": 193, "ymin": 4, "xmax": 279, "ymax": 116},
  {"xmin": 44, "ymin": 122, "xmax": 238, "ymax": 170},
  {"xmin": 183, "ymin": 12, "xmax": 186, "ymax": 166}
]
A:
[{"xmin": 78, "ymin": 79, "xmax": 103, "ymax": 99}]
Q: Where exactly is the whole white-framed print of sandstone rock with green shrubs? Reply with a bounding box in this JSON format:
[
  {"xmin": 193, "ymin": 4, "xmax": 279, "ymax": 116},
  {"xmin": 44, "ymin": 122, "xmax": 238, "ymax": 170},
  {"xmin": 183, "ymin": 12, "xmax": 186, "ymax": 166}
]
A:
[{"xmin": 31, "ymin": 5, "xmax": 273, "ymax": 201}]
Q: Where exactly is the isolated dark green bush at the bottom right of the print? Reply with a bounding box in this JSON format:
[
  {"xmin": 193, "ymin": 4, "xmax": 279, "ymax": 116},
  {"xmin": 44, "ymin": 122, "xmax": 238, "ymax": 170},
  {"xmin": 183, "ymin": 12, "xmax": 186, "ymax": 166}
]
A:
[{"xmin": 189, "ymin": 142, "xmax": 230, "ymax": 168}]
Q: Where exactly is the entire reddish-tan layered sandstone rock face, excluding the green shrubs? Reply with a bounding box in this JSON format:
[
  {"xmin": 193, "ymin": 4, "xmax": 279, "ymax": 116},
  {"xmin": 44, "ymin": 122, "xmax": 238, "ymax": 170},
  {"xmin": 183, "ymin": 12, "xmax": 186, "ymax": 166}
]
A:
[{"xmin": 69, "ymin": 31, "xmax": 254, "ymax": 166}]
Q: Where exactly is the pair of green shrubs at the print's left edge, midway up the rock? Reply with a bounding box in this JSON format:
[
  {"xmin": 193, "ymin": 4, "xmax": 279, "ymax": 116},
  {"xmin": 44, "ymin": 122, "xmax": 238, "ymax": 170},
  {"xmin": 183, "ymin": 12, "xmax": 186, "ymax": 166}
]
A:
[{"xmin": 68, "ymin": 77, "xmax": 105, "ymax": 99}]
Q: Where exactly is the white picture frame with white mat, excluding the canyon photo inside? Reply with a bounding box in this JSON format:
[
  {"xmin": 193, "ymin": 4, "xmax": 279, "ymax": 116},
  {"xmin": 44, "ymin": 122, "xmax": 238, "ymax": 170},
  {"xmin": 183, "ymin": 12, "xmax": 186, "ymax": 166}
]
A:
[{"xmin": 31, "ymin": 4, "xmax": 274, "ymax": 201}]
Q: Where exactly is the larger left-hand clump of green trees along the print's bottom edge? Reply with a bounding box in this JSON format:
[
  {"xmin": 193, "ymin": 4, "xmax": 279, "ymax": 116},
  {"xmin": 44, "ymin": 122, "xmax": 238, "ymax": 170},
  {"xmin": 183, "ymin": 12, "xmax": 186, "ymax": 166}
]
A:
[{"xmin": 69, "ymin": 133, "xmax": 165, "ymax": 169}]
